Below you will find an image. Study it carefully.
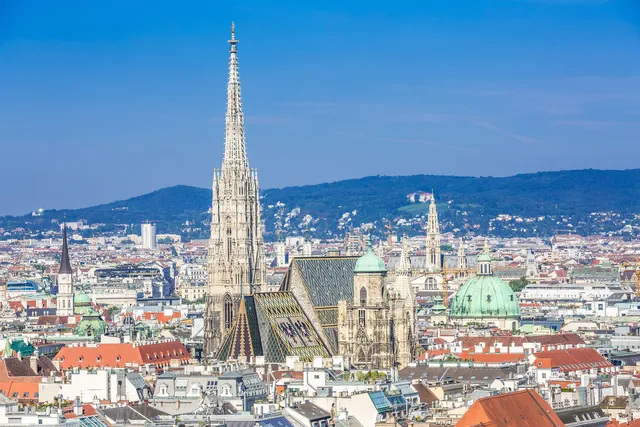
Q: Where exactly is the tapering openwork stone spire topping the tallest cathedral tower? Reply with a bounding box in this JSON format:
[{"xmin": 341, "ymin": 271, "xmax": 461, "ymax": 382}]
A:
[{"xmin": 222, "ymin": 23, "xmax": 249, "ymax": 169}]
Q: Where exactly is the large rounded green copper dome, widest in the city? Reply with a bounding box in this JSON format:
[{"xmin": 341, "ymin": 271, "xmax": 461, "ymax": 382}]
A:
[{"xmin": 449, "ymin": 276, "xmax": 520, "ymax": 318}]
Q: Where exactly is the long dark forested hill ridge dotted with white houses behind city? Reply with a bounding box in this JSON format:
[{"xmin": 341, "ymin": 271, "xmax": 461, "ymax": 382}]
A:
[{"xmin": 0, "ymin": 169, "xmax": 640, "ymax": 239}]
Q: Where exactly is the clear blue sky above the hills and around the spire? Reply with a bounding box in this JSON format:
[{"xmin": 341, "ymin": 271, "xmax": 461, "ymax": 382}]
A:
[{"xmin": 0, "ymin": 0, "xmax": 640, "ymax": 214}]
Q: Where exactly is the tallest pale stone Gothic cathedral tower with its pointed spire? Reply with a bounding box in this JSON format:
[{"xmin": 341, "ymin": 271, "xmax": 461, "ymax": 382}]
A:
[{"xmin": 204, "ymin": 24, "xmax": 266, "ymax": 357}]
